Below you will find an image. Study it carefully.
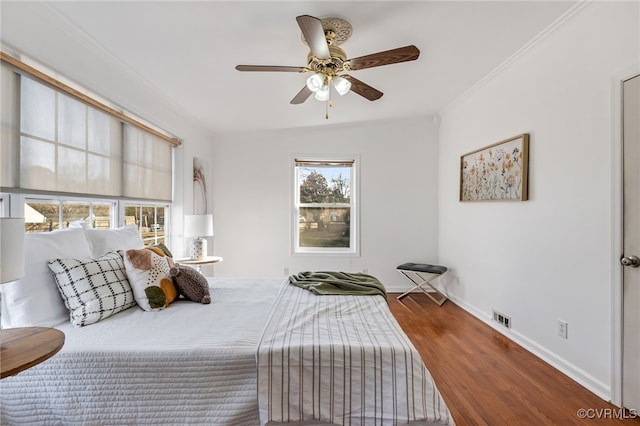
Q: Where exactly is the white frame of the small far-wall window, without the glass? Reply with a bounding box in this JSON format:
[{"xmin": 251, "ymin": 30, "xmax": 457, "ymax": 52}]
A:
[{"xmin": 290, "ymin": 154, "xmax": 360, "ymax": 257}]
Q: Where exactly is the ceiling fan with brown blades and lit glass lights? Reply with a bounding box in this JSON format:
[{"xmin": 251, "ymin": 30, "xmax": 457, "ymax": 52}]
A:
[{"xmin": 236, "ymin": 15, "xmax": 420, "ymax": 118}]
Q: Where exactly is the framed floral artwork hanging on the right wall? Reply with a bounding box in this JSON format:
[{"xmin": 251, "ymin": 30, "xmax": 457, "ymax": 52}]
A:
[{"xmin": 460, "ymin": 133, "xmax": 529, "ymax": 201}]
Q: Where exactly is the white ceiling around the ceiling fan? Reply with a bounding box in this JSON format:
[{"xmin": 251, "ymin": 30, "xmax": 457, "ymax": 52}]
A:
[{"xmin": 0, "ymin": 1, "xmax": 576, "ymax": 134}]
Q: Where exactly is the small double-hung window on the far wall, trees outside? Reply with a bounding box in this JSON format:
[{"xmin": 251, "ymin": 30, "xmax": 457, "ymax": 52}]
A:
[{"xmin": 293, "ymin": 159, "xmax": 357, "ymax": 254}]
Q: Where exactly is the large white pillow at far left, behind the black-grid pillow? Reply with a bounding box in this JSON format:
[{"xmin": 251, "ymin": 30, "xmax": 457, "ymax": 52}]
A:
[{"xmin": 1, "ymin": 228, "xmax": 91, "ymax": 328}]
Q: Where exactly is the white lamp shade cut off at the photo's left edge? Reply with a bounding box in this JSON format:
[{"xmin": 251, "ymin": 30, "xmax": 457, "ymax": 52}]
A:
[{"xmin": 0, "ymin": 217, "xmax": 24, "ymax": 284}]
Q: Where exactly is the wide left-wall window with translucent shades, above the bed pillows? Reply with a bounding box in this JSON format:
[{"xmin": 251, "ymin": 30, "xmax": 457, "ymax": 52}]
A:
[{"xmin": 0, "ymin": 61, "xmax": 179, "ymax": 244}]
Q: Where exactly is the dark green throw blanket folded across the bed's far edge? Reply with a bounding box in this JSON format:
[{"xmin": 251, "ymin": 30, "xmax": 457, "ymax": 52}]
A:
[{"xmin": 289, "ymin": 271, "xmax": 388, "ymax": 302}]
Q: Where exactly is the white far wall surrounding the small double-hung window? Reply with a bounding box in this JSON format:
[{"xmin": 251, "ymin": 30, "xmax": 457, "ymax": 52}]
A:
[{"xmin": 213, "ymin": 117, "xmax": 438, "ymax": 290}]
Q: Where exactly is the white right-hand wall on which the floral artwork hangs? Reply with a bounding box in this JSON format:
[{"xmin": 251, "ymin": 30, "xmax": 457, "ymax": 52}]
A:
[{"xmin": 439, "ymin": 2, "xmax": 640, "ymax": 399}]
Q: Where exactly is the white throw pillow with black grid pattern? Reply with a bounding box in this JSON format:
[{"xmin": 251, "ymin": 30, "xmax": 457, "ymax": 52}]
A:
[{"xmin": 49, "ymin": 251, "xmax": 136, "ymax": 327}]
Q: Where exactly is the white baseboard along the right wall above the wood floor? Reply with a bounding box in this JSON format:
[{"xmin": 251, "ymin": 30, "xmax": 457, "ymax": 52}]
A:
[{"xmin": 450, "ymin": 296, "xmax": 611, "ymax": 402}]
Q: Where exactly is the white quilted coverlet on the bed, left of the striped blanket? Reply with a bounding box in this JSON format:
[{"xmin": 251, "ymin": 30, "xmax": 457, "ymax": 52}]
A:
[{"xmin": 0, "ymin": 279, "xmax": 282, "ymax": 425}]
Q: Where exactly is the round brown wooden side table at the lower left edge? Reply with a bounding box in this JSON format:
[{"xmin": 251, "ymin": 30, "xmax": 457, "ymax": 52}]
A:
[{"xmin": 0, "ymin": 327, "xmax": 64, "ymax": 379}]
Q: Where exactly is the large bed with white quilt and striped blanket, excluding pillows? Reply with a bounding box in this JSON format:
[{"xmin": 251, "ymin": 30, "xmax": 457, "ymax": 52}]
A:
[{"xmin": 0, "ymin": 226, "xmax": 453, "ymax": 425}]
